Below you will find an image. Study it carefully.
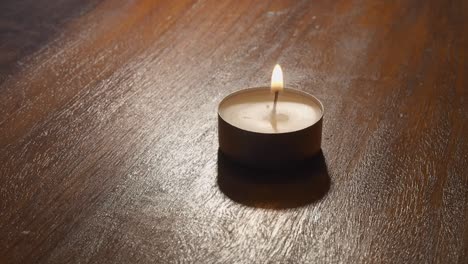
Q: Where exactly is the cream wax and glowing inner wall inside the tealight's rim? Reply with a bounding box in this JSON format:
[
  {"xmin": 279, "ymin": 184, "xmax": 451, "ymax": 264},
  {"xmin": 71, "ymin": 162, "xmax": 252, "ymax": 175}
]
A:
[{"xmin": 219, "ymin": 88, "xmax": 323, "ymax": 134}]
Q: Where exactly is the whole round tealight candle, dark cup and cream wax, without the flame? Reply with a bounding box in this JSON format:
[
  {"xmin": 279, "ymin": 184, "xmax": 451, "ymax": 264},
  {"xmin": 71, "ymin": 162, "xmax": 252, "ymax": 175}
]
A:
[{"xmin": 218, "ymin": 87, "xmax": 323, "ymax": 168}]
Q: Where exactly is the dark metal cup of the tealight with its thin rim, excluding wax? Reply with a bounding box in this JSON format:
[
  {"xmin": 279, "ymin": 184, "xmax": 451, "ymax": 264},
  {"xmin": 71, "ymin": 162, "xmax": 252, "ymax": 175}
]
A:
[{"xmin": 218, "ymin": 88, "xmax": 324, "ymax": 169}]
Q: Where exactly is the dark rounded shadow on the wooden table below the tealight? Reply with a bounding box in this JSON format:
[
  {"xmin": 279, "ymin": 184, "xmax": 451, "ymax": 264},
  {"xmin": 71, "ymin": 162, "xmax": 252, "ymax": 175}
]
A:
[{"xmin": 217, "ymin": 151, "xmax": 331, "ymax": 209}]
